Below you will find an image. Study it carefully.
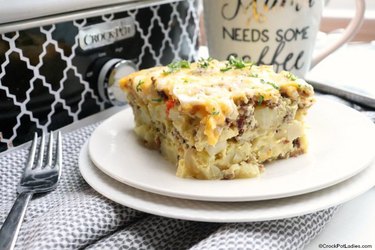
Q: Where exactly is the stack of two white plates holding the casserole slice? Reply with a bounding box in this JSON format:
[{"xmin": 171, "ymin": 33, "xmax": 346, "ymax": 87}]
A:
[{"xmin": 79, "ymin": 98, "xmax": 375, "ymax": 222}]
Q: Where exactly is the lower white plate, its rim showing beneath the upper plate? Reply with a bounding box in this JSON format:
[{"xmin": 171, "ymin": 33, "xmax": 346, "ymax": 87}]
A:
[{"xmin": 79, "ymin": 143, "xmax": 375, "ymax": 222}]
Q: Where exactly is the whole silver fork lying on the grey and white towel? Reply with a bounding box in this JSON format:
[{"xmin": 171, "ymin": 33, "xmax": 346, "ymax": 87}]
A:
[{"xmin": 0, "ymin": 132, "xmax": 62, "ymax": 250}]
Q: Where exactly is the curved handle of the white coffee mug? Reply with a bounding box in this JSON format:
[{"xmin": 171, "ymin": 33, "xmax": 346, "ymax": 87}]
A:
[{"xmin": 310, "ymin": 0, "xmax": 366, "ymax": 69}]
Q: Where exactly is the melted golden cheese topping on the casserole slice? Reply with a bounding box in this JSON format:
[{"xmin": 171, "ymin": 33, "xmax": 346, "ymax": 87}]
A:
[{"xmin": 120, "ymin": 60, "xmax": 313, "ymax": 145}]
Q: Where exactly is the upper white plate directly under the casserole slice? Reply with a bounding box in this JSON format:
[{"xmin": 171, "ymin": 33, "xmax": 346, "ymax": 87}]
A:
[{"xmin": 89, "ymin": 98, "xmax": 375, "ymax": 201}]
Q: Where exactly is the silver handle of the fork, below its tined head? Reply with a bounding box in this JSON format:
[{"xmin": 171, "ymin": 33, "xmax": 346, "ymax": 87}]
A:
[{"xmin": 0, "ymin": 192, "xmax": 33, "ymax": 250}]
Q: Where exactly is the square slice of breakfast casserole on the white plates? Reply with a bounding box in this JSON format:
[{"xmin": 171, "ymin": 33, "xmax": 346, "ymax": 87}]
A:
[{"xmin": 120, "ymin": 58, "xmax": 314, "ymax": 179}]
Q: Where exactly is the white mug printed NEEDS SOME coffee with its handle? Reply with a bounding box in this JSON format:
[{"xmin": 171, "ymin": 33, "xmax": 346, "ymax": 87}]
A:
[{"xmin": 203, "ymin": 0, "xmax": 365, "ymax": 77}]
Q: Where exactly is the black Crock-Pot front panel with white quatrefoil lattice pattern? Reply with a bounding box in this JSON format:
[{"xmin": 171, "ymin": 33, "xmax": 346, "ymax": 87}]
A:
[{"xmin": 0, "ymin": 0, "xmax": 199, "ymax": 152}]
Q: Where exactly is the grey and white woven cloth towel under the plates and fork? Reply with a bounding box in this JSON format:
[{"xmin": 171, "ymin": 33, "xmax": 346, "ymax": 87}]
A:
[{"xmin": 0, "ymin": 94, "xmax": 375, "ymax": 250}]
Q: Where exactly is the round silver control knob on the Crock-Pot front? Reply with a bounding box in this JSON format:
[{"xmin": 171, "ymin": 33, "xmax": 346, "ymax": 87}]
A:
[{"xmin": 98, "ymin": 58, "xmax": 137, "ymax": 106}]
